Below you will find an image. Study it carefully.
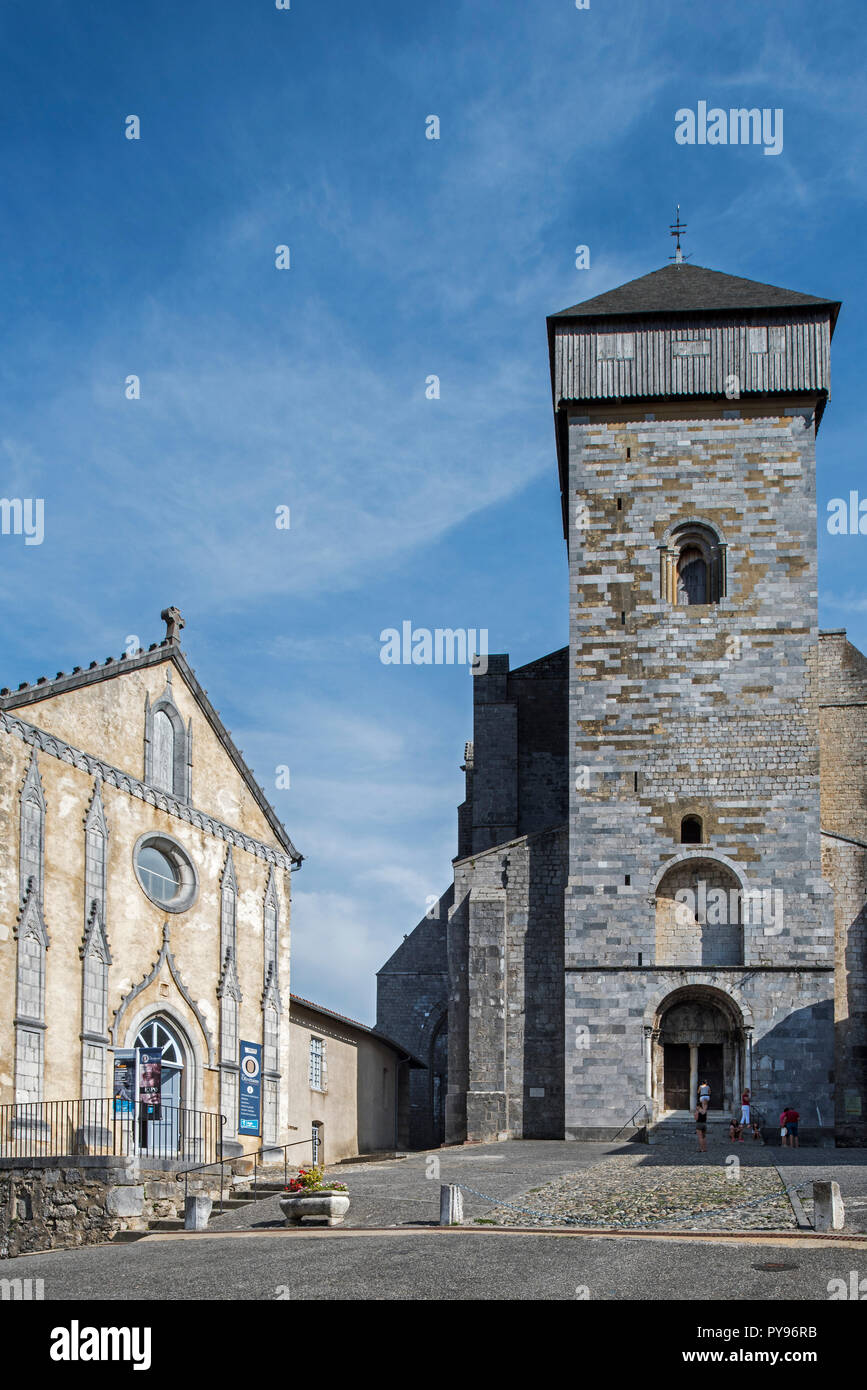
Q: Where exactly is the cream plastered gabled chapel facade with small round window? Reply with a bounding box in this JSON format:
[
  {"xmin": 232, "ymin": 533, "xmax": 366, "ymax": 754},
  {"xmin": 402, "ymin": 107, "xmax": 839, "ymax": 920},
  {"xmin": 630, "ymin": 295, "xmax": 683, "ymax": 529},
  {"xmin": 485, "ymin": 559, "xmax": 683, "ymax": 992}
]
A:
[{"xmin": 0, "ymin": 609, "xmax": 302, "ymax": 1159}]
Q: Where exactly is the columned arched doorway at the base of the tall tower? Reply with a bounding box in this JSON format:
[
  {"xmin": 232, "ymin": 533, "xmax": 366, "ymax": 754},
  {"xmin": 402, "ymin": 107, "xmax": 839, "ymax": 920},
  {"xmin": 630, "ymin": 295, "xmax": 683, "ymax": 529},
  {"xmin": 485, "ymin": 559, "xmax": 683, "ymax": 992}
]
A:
[{"xmin": 647, "ymin": 986, "xmax": 749, "ymax": 1118}]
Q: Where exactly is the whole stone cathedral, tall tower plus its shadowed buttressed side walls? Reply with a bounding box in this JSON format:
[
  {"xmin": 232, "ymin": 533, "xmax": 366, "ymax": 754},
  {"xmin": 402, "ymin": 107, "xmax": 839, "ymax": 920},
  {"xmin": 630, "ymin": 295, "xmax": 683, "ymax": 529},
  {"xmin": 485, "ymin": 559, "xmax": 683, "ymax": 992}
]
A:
[{"xmin": 378, "ymin": 261, "xmax": 867, "ymax": 1147}]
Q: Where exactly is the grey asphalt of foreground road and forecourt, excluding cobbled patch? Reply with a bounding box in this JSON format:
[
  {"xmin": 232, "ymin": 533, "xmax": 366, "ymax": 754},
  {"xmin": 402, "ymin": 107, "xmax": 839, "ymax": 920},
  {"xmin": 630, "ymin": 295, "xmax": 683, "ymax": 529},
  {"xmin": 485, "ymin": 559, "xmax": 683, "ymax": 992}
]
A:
[{"xmin": 0, "ymin": 1141, "xmax": 867, "ymax": 1301}]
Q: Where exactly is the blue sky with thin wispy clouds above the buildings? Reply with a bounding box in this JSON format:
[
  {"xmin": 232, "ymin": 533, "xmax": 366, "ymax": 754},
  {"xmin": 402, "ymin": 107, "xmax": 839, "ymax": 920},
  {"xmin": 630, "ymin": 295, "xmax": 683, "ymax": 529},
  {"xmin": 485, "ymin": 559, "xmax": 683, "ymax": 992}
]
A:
[{"xmin": 0, "ymin": 0, "xmax": 867, "ymax": 1020}]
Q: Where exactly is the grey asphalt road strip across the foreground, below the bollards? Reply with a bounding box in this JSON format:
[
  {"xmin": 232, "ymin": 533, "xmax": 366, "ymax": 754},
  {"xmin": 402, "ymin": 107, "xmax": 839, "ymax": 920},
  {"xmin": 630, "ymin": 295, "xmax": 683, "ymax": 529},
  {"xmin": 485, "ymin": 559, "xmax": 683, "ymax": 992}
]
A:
[{"xmin": 3, "ymin": 1229, "xmax": 867, "ymax": 1301}]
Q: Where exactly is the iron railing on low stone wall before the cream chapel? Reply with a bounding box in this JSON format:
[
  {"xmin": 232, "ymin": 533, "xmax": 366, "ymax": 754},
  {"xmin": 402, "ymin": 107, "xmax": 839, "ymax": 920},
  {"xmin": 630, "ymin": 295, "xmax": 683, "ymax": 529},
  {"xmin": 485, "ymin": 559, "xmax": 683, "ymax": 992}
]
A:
[{"xmin": 0, "ymin": 1097, "xmax": 224, "ymax": 1162}]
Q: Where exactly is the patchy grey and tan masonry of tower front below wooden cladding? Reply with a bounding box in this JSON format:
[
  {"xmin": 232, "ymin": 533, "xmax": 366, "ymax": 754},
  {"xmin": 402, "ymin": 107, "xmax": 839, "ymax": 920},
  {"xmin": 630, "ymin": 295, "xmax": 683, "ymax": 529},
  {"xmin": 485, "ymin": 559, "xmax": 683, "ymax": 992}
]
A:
[{"xmin": 565, "ymin": 404, "xmax": 834, "ymax": 1131}]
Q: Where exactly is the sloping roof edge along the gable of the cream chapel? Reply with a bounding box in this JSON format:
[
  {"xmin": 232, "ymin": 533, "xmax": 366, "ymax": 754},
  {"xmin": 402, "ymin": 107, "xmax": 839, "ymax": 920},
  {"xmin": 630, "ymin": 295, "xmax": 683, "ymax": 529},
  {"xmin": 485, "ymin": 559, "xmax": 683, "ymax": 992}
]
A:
[{"xmin": 0, "ymin": 639, "xmax": 304, "ymax": 865}]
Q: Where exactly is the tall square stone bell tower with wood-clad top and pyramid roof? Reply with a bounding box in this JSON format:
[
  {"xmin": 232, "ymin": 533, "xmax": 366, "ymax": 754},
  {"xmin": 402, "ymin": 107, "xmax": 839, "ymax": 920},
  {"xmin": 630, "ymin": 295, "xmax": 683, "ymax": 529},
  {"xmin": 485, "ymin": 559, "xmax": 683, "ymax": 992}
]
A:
[{"xmin": 549, "ymin": 263, "xmax": 839, "ymax": 1137}]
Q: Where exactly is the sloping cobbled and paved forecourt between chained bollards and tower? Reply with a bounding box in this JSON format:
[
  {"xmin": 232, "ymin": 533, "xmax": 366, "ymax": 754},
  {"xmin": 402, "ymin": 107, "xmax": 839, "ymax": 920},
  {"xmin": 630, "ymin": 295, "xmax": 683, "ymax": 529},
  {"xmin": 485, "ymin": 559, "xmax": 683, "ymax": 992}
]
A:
[{"xmin": 201, "ymin": 1140, "xmax": 867, "ymax": 1232}]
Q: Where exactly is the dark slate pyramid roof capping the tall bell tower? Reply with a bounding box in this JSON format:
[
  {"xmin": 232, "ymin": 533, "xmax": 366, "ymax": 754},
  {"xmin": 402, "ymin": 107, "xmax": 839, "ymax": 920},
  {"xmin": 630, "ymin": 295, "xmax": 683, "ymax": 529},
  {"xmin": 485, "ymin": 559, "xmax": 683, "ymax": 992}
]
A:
[{"xmin": 549, "ymin": 261, "xmax": 841, "ymax": 325}]
